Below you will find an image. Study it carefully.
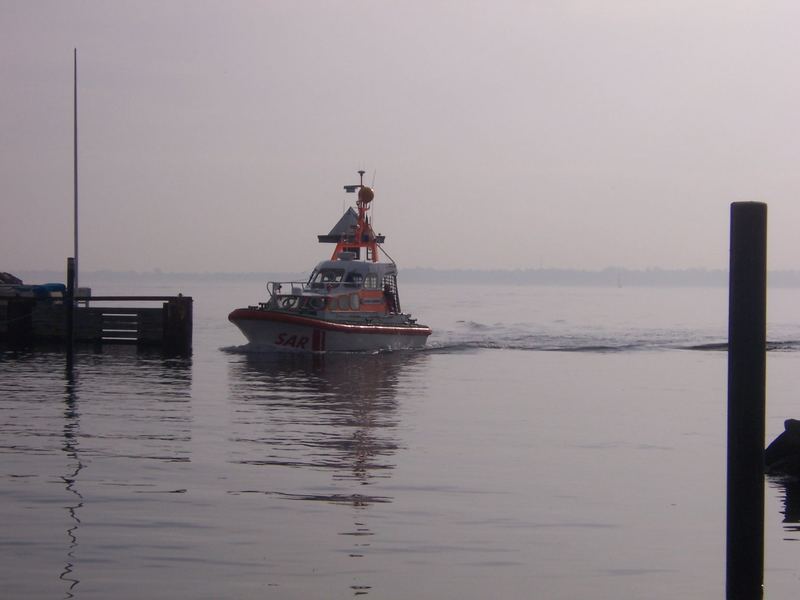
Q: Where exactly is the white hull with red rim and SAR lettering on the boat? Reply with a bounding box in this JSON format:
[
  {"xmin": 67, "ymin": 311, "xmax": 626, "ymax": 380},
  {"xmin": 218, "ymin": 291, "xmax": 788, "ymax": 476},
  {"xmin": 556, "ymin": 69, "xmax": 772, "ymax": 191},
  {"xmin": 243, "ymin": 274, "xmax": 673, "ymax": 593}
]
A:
[{"xmin": 228, "ymin": 308, "xmax": 431, "ymax": 352}]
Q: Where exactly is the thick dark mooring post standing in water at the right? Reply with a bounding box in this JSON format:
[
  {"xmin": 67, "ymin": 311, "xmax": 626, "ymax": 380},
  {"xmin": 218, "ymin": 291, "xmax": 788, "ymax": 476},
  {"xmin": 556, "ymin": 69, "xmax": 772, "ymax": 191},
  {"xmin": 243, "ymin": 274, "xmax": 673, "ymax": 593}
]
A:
[{"xmin": 725, "ymin": 202, "xmax": 767, "ymax": 600}]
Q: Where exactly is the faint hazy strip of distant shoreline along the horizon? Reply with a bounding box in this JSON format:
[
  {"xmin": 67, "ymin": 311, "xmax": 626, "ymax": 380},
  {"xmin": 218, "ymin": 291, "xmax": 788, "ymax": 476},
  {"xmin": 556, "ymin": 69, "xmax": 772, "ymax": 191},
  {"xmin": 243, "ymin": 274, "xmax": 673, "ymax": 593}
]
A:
[{"xmin": 11, "ymin": 267, "xmax": 800, "ymax": 287}]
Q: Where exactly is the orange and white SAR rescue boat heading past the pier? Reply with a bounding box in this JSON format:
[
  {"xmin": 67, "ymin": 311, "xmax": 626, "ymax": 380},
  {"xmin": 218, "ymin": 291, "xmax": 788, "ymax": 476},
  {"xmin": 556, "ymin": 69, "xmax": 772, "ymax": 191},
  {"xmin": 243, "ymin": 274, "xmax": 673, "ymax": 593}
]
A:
[{"xmin": 228, "ymin": 171, "xmax": 431, "ymax": 352}]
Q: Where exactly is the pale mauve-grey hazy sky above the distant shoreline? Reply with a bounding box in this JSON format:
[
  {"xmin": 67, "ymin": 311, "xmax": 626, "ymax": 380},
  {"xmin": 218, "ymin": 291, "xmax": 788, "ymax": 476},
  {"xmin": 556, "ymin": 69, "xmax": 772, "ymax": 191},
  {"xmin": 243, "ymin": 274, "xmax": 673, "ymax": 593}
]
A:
[{"xmin": 0, "ymin": 0, "xmax": 800, "ymax": 272}]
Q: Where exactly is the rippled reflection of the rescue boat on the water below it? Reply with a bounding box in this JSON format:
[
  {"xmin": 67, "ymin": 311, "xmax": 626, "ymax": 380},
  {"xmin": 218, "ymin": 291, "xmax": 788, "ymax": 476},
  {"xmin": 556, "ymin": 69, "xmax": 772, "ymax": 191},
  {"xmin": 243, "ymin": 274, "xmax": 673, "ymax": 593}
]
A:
[{"xmin": 228, "ymin": 352, "xmax": 429, "ymax": 596}]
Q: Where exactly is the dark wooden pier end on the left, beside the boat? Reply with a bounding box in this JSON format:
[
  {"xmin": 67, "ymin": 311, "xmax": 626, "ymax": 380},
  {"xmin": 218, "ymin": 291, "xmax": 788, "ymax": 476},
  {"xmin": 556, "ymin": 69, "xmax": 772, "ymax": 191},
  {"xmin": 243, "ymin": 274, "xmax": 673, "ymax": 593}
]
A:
[{"xmin": 0, "ymin": 295, "xmax": 192, "ymax": 354}]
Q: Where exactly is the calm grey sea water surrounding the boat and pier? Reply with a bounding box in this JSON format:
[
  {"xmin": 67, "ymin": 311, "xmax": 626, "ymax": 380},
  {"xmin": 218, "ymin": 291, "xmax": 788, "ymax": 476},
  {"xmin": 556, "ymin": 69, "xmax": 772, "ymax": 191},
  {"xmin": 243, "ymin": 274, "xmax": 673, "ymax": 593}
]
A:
[{"xmin": 0, "ymin": 273, "xmax": 800, "ymax": 600}]
